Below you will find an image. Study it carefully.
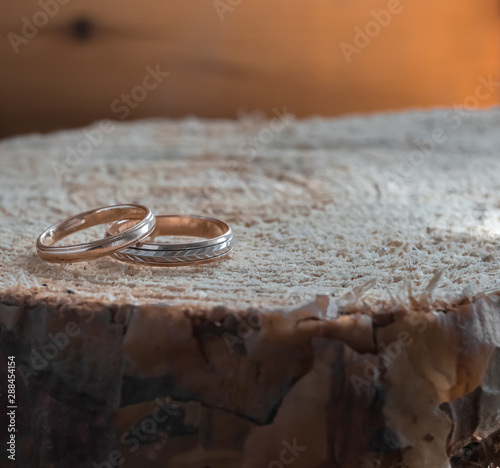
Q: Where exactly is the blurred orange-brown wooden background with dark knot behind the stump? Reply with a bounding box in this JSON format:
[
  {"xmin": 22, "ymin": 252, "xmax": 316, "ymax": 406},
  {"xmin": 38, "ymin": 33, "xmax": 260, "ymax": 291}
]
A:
[{"xmin": 0, "ymin": 0, "xmax": 500, "ymax": 136}]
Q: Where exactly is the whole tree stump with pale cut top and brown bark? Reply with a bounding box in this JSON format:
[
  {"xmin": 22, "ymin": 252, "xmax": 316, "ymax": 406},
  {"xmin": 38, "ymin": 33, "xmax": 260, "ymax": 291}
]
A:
[{"xmin": 0, "ymin": 109, "xmax": 500, "ymax": 468}]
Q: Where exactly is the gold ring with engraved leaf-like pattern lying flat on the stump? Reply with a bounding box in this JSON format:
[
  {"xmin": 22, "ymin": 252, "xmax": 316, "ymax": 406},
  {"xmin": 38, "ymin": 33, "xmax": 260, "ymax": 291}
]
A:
[{"xmin": 106, "ymin": 215, "xmax": 233, "ymax": 266}]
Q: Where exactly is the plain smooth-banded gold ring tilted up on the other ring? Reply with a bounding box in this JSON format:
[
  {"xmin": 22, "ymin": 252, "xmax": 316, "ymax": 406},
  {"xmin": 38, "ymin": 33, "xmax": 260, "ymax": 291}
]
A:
[{"xmin": 36, "ymin": 205, "xmax": 156, "ymax": 263}]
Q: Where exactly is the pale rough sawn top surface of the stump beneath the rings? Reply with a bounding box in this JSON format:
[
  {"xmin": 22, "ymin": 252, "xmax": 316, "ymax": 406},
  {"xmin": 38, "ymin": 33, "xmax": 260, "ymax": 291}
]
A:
[{"xmin": 0, "ymin": 110, "xmax": 500, "ymax": 308}]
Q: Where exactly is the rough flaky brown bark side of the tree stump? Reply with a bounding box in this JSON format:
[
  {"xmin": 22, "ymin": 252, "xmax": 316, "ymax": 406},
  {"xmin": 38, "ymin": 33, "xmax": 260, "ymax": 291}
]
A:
[{"xmin": 0, "ymin": 294, "xmax": 500, "ymax": 468}]
